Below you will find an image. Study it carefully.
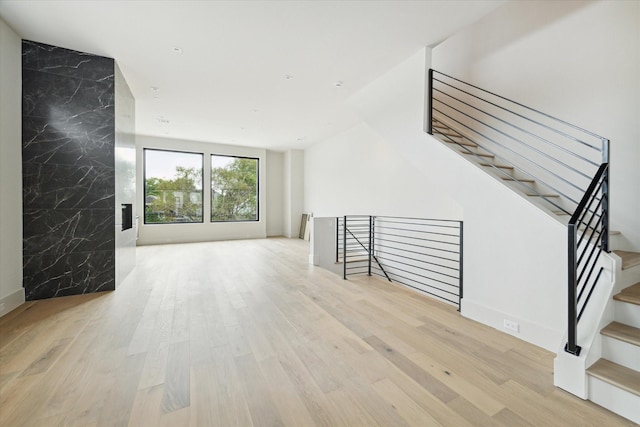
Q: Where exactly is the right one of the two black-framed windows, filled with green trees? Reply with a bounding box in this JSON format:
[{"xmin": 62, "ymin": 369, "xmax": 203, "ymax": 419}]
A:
[{"xmin": 211, "ymin": 154, "xmax": 259, "ymax": 222}]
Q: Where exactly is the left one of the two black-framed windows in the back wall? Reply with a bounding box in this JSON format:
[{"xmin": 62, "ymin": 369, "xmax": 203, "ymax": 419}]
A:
[{"xmin": 144, "ymin": 149, "xmax": 204, "ymax": 224}]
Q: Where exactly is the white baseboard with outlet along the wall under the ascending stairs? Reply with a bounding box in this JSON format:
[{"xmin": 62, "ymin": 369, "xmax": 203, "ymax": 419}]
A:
[{"xmin": 460, "ymin": 298, "xmax": 564, "ymax": 353}]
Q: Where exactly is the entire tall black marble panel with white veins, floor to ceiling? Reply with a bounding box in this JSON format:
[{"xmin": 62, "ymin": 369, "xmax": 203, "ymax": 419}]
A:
[{"xmin": 22, "ymin": 40, "xmax": 115, "ymax": 300}]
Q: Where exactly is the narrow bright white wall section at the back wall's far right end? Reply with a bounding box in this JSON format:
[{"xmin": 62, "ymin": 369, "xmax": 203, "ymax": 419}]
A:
[{"xmin": 284, "ymin": 150, "xmax": 305, "ymax": 237}]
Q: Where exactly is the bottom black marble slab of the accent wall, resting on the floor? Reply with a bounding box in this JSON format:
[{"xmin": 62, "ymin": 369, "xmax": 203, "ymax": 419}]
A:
[{"xmin": 23, "ymin": 250, "xmax": 115, "ymax": 301}]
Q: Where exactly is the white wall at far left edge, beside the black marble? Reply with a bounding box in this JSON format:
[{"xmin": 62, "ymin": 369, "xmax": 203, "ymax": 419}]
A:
[{"xmin": 0, "ymin": 19, "xmax": 24, "ymax": 316}]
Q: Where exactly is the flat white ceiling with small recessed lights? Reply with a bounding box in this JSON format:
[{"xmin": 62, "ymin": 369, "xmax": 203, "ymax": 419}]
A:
[{"xmin": 0, "ymin": 0, "xmax": 502, "ymax": 149}]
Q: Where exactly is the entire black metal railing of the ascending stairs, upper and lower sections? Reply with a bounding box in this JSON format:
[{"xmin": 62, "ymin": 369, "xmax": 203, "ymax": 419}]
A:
[{"xmin": 427, "ymin": 69, "xmax": 609, "ymax": 355}]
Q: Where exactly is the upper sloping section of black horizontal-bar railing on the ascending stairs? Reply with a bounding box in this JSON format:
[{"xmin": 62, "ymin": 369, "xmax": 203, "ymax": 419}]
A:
[{"xmin": 427, "ymin": 70, "xmax": 608, "ymax": 215}]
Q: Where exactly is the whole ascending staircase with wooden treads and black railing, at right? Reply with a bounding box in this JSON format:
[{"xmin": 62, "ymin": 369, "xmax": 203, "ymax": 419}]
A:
[{"xmin": 428, "ymin": 70, "xmax": 640, "ymax": 424}]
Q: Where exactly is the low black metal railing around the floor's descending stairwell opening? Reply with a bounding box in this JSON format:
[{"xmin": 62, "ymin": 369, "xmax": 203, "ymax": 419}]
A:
[{"xmin": 336, "ymin": 216, "xmax": 463, "ymax": 308}]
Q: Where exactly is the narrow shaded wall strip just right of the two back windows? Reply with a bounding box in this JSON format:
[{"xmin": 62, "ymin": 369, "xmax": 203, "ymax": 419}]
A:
[{"xmin": 266, "ymin": 150, "xmax": 284, "ymax": 237}]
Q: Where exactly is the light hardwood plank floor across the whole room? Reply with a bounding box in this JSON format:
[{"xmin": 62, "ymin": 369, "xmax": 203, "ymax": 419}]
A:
[{"xmin": 0, "ymin": 239, "xmax": 632, "ymax": 427}]
